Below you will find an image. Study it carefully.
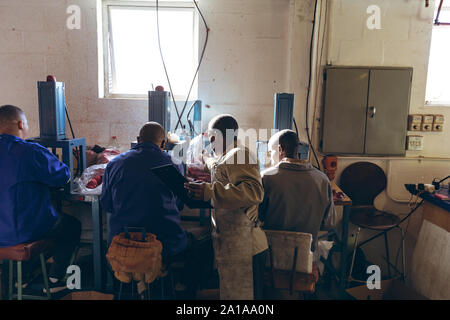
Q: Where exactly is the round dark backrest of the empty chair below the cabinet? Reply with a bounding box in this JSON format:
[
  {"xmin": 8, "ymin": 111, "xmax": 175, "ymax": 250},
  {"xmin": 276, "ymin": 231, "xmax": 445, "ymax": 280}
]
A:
[{"xmin": 340, "ymin": 161, "xmax": 387, "ymax": 205}]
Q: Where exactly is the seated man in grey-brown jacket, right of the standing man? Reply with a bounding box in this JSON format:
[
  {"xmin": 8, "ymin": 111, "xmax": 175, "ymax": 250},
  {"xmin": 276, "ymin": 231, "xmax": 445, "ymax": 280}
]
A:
[{"xmin": 259, "ymin": 130, "xmax": 336, "ymax": 251}]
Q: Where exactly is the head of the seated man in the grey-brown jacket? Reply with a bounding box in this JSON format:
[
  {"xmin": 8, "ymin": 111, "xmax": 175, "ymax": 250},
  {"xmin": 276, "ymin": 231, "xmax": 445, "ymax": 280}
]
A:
[{"xmin": 268, "ymin": 129, "xmax": 301, "ymax": 166}]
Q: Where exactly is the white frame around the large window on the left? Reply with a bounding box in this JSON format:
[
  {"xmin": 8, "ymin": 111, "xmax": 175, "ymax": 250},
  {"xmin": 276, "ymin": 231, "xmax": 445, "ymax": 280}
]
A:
[{"xmin": 98, "ymin": 0, "xmax": 199, "ymax": 100}]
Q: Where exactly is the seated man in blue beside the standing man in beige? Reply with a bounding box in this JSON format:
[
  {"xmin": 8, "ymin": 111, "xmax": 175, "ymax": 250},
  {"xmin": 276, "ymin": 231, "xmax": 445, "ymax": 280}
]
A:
[{"xmin": 100, "ymin": 122, "xmax": 187, "ymax": 261}]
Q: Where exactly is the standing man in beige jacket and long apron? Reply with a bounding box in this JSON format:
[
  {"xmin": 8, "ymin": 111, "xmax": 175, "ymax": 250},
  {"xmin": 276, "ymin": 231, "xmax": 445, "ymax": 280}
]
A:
[{"xmin": 186, "ymin": 115, "xmax": 268, "ymax": 300}]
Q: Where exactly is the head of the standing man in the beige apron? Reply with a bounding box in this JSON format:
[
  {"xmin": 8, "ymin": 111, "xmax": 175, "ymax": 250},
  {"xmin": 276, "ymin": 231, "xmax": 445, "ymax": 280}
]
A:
[{"xmin": 208, "ymin": 114, "xmax": 239, "ymax": 154}]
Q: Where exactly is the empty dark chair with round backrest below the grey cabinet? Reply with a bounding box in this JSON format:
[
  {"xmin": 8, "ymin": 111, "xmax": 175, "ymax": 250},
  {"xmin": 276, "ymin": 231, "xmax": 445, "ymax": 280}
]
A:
[{"xmin": 340, "ymin": 162, "xmax": 405, "ymax": 281}]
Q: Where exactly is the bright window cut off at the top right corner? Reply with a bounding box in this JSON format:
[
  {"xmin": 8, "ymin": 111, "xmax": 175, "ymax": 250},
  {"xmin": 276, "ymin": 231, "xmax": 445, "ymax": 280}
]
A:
[{"xmin": 426, "ymin": 0, "xmax": 450, "ymax": 106}]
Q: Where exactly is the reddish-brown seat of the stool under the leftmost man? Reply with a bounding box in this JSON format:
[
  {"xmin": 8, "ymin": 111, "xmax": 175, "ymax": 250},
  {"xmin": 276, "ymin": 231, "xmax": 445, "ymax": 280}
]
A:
[{"xmin": 0, "ymin": 240, "xmax": 53, "ymax": 261}]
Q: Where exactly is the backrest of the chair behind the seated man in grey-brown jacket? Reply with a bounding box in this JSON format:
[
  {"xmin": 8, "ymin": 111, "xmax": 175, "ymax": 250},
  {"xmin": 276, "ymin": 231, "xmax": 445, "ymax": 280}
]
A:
[{"xmin": 264, "ymin": 230, "xmax": 313, "ymax": 273}]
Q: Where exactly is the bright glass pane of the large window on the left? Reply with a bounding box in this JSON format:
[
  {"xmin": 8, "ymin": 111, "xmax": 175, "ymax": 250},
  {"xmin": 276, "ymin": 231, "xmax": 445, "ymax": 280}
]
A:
[{"xmin": 110, "ymin": 6, "xmax": 197, "ymax": 98}]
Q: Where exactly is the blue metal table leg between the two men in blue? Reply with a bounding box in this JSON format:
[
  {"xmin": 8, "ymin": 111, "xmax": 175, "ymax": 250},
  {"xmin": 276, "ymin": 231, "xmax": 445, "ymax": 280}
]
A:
[{"xmin": 91, "ymin": 196, "xmax": 104, "ymax": 291}]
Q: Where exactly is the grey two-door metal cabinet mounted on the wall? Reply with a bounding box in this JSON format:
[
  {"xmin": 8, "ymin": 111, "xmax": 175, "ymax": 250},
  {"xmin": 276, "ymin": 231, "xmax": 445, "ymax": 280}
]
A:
[{"xmin": 321, "ymin": 66, "xmax": 412, "ymax": 155}]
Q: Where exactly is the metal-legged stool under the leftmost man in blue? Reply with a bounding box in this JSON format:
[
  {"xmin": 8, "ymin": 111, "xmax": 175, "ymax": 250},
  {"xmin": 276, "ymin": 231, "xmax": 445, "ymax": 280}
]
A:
[{"xmin": 0, "ymin": 240, "xmax": 53, "ymax": 300}]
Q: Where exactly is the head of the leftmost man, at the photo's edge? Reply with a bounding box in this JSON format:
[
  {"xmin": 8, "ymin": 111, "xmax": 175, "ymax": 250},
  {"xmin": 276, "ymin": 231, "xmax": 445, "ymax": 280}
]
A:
[{"xmin": 0, "ymin": 105, "xmax": 28, "ymax": 139}]
